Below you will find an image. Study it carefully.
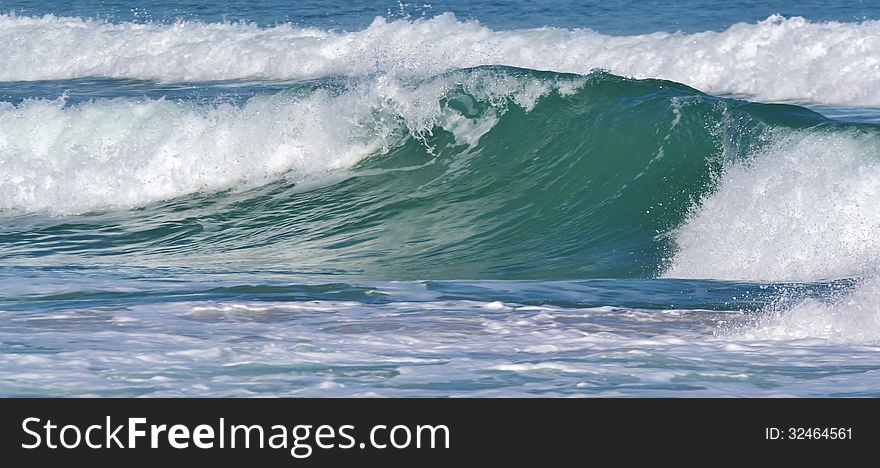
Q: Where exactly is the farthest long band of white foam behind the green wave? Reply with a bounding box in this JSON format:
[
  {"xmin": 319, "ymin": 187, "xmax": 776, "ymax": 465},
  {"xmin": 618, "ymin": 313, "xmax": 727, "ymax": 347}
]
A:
[{"xmin": 0, "ymin": 13, "xmax": 880, "ymax": 106}]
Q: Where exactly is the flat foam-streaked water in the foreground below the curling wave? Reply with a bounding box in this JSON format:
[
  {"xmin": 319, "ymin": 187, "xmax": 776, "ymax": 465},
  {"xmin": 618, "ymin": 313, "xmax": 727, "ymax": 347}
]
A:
[{"xmin": 0, "ymin": 294, "xmax": 878, "ymax": 397}]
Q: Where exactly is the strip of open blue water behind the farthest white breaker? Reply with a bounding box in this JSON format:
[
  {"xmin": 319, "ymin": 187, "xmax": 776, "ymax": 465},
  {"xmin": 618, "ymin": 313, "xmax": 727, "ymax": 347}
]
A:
[{"xmin": 0, "ymin": 0, "xmax": 880, "ymax": 31}]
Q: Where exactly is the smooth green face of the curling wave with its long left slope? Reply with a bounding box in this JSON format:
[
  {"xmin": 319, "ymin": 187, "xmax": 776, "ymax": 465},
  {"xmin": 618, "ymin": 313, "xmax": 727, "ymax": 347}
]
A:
[{"xmin": 0, "ymin": 68, "xmax": 840, "ymax": 280}]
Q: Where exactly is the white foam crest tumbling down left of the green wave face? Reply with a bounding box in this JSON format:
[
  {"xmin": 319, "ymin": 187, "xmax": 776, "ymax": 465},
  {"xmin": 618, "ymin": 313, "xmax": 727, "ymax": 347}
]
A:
[{"xmin": 0, "ymin": 70, "xmax": 578, "ymax": 214}]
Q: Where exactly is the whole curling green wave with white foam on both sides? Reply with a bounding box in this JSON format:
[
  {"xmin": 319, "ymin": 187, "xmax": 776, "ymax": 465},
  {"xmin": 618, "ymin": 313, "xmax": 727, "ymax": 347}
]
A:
[{"xmin": 0, "ymin": 67, "xmax": 880, "ymax": 282}]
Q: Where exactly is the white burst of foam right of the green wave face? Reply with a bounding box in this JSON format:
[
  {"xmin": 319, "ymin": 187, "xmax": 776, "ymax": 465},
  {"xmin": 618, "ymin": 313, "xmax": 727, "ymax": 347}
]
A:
[{"xmin": 665, "ymin": 130, "xmax": 880, "ymax": 281}]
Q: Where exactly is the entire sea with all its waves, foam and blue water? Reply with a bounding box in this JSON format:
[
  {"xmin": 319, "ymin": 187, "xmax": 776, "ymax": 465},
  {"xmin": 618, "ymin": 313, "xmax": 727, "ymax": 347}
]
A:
[{"xmin": 0, "ymin": 0, "xmax": 880, "ymax": 397}]
